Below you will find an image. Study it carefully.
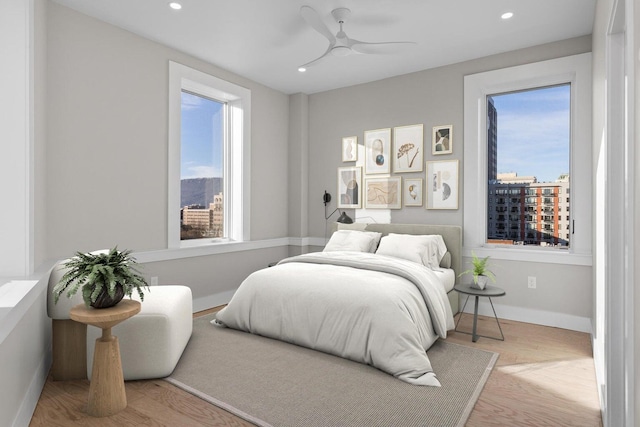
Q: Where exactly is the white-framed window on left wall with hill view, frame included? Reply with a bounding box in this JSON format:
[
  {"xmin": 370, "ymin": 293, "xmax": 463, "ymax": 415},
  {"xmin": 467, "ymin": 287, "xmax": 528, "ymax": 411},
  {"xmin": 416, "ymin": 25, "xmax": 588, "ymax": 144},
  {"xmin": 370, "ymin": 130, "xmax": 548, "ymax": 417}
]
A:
[{"xmin": 167, "ymin": 62, "xmax": 251, "ymax": 248}]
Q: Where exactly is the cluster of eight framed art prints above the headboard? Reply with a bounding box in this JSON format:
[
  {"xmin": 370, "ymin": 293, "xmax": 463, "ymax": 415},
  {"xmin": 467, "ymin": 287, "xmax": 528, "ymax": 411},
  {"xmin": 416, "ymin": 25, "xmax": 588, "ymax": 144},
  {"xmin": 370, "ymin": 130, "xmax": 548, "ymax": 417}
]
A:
[{"xmin": 338, "ymin": 124, "xmax": 459, "ymax": 209}]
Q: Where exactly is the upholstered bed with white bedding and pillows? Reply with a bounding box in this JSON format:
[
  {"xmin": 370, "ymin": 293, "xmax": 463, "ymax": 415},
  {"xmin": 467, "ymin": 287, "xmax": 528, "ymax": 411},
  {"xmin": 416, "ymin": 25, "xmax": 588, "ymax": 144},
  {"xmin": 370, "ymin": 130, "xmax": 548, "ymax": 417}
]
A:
[{"xmin": 212, "ymin": 223, "xmax": 462, "ymax": 386}]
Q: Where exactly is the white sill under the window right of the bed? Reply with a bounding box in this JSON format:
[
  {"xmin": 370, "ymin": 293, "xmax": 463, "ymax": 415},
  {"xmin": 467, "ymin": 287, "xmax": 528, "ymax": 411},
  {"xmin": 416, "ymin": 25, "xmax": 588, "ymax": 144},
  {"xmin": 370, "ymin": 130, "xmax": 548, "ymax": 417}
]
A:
[{"xmin": 462, "ymin": 246, "xmax": 593, "ymax": 266}]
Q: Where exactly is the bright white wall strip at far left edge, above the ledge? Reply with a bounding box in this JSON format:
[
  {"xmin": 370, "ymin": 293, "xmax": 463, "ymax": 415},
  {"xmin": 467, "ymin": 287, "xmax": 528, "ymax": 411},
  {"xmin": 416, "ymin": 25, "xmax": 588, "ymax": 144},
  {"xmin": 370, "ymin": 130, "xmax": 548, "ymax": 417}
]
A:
[{"xmin": 0, "ymin": 0, "xmax": 35, "ymax": 276}]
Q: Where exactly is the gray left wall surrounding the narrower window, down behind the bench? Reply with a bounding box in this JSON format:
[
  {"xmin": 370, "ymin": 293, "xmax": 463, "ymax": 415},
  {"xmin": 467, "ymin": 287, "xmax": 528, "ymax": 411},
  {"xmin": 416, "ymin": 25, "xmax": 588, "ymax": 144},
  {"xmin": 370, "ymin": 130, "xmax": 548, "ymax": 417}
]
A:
[{"xmin": 45, "ymin": 3, "xmax": 289, "ymax": 299}]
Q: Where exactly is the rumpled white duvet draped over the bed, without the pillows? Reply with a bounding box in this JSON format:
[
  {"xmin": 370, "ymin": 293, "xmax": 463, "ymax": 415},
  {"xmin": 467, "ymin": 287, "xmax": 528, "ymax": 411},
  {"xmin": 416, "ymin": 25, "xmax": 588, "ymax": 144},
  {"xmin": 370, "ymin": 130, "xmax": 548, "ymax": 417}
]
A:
[{"xmin": 212, "ymin": 252, "xmax": 454, "ymax": 386}]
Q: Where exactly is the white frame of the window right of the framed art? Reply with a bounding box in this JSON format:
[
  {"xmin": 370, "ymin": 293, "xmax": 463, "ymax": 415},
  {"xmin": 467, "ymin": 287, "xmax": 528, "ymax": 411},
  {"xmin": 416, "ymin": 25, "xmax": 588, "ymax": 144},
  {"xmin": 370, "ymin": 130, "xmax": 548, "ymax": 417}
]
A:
[{"xmin": 463, "ymin": 53, "xmax": 592, "ymax": 265}]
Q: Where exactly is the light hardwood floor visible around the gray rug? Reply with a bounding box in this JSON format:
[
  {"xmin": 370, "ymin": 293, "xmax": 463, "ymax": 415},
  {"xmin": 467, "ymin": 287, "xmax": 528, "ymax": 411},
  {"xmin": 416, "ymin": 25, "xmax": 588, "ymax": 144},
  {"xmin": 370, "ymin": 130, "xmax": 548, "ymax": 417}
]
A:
[{"xmin": 30, "ymin": 310, "xmax": 602, "ymax": 427}]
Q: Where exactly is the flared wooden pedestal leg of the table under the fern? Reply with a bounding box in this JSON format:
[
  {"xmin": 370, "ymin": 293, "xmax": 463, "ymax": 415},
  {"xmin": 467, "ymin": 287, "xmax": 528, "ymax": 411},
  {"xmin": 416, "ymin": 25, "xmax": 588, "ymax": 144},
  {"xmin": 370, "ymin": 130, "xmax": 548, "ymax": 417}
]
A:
[{"xmin": 87, "ymin": 334, "xmax": 127, "ymax": 417}]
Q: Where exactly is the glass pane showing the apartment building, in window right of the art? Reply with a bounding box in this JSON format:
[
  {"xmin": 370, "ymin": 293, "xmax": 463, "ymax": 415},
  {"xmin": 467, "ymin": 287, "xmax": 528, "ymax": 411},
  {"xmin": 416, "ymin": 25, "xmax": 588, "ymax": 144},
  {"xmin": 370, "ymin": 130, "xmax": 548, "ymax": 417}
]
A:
[{"xmin": 487, "ymin": 84, "xmax": 571, "ymax": 248}]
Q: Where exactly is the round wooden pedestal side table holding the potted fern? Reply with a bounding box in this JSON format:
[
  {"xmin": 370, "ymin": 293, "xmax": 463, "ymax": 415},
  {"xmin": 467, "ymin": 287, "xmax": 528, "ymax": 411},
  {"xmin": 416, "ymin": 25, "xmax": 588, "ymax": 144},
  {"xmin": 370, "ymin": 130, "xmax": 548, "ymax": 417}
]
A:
[{"xmin": 69, "ymin": 299, "xmax": 140, "ymax": 417}]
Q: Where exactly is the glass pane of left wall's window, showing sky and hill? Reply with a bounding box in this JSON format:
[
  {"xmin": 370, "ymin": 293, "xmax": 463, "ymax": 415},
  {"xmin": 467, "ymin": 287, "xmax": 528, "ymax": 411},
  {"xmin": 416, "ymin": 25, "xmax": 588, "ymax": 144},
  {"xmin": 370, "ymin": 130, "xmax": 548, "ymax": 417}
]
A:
[{"xmin": 180, "ymin": 90, "xmax": 226, "ymax": 240}]
